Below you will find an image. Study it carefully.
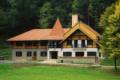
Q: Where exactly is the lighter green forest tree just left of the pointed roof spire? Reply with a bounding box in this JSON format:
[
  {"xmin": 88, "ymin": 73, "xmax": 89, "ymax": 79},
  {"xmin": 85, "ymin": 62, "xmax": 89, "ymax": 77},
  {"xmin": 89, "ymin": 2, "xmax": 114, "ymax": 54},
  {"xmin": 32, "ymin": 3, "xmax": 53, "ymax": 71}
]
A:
[{"xmin": 39, "ymin": 2, "xmax": 54, "ymax": 28}]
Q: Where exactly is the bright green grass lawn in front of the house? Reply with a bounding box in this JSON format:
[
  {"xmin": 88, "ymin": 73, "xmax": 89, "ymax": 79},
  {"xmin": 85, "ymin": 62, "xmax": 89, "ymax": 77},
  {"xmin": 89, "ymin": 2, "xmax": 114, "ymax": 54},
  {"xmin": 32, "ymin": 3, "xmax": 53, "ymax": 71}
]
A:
[{"xmin": 0, "ymin": 64, "xmax": 120, "ymax": 80}]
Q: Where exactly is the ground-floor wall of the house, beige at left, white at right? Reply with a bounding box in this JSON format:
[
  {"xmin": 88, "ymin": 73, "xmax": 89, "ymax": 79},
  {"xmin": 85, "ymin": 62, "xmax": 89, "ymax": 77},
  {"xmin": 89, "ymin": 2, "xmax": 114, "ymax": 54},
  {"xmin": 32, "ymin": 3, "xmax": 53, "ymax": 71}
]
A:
[{"xmin": 12, "ymin": 48, "xmax": 99, "ymax": 61}]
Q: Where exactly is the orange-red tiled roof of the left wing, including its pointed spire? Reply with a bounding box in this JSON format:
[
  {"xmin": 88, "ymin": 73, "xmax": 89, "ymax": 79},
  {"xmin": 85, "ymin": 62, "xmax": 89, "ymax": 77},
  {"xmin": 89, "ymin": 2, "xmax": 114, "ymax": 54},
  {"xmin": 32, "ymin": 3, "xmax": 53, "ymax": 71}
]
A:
[{"xmin": 8, "ymin": 19, "xmax": 69, "ymax": 41}]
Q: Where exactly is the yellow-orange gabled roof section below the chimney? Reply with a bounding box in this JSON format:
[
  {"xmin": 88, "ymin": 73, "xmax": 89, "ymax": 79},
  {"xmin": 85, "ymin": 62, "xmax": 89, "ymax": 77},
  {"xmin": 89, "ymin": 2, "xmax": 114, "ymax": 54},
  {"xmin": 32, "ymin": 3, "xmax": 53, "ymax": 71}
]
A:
[{"xmin": 63, "ymin": 22, "xmax": 99, "ymax": 42}]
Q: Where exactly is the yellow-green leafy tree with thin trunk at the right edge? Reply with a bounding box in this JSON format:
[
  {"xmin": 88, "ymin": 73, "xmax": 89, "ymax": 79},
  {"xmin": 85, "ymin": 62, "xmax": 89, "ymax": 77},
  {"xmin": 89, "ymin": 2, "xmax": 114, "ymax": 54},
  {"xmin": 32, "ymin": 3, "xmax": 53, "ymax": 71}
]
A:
[{"xmin": 100, "ymin": 0, "xmax": 120, "ymax": 71}]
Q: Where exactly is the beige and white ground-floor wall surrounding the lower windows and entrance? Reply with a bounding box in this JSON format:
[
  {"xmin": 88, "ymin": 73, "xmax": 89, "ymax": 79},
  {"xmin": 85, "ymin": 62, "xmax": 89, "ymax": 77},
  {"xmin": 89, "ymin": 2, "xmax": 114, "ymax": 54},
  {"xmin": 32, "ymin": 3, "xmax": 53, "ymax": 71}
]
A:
[{"xmin": 12, "ymin": 48, "xmax": 99, "ymax": 60}]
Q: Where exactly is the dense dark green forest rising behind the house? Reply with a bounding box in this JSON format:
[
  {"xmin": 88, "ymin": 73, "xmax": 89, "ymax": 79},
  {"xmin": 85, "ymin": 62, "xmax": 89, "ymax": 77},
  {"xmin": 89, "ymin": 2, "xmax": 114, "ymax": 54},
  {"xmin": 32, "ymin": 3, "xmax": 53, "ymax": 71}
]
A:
[{"xmin": 0, "ymin": 0, "xmax": 115, "ymax": 39}]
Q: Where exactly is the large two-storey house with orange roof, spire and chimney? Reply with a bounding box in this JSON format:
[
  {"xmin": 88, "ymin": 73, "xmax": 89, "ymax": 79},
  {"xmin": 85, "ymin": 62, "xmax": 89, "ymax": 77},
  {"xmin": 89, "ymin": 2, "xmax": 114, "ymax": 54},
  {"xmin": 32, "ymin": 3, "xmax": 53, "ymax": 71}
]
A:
[{"xmin": 8, "ymin": 15, "xmax": 100, "ymax": 60}]
